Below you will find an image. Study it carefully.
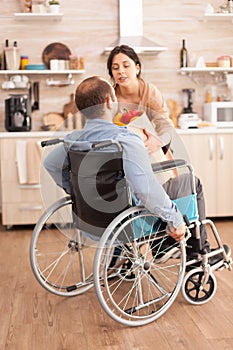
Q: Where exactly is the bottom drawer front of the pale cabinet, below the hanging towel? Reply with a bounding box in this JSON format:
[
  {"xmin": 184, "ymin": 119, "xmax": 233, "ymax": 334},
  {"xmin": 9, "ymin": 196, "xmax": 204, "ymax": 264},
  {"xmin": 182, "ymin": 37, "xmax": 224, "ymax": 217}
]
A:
[{"xmin": 2, "ymin": 203, "xmax": 44, "ymax": 225}]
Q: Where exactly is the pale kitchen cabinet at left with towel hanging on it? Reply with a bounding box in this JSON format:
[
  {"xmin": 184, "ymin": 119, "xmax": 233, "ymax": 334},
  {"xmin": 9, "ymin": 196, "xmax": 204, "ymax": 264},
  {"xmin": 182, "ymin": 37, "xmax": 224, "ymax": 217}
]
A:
[{"xmin": 0, "ymin": 132, "xmax": 65, "ymax": 228}]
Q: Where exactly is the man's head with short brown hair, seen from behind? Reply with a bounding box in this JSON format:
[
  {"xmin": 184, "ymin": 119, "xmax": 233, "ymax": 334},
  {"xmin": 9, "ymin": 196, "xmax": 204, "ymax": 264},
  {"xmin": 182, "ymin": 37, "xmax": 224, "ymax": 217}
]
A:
[{"xmin": 75, "ymin": 76, "xmax": 116, "ymax": 119}]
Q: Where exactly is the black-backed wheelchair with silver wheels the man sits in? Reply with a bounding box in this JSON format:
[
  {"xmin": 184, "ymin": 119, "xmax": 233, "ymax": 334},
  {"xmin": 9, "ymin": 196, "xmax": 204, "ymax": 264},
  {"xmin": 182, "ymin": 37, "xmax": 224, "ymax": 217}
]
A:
[{"xmin": 30, "ymin": 139, "xmax": 232, "ymax": 326}]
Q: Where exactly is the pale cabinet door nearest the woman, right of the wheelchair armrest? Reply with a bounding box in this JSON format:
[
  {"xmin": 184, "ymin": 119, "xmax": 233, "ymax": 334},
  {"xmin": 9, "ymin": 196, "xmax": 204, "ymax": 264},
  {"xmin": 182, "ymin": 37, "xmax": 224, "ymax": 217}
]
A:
[{"xmin": 180, "ymin": 134, "xmax": 218, "ymax": 216}]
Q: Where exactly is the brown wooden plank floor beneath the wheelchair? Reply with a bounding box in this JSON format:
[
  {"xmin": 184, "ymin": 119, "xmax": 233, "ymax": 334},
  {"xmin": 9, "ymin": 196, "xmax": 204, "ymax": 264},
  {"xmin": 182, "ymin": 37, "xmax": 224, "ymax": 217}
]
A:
[{"xmin": 0, "ymin": 219, "xmax": 233, "ymax": 350}]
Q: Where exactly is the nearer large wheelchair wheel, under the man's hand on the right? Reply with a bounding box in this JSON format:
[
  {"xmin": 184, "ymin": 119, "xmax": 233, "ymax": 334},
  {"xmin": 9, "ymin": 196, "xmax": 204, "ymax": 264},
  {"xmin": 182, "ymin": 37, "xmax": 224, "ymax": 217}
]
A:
[{"xmin": 94, "ymin": 207, "xmax": 186, "ymax": 326}]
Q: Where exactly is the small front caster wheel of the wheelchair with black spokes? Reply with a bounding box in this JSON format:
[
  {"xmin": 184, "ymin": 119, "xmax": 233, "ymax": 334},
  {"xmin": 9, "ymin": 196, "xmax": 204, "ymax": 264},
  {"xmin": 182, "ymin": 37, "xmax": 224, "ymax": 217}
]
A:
[{"xmin": 181, "ymin": 268, "xmax": 217, "ymax": 305}]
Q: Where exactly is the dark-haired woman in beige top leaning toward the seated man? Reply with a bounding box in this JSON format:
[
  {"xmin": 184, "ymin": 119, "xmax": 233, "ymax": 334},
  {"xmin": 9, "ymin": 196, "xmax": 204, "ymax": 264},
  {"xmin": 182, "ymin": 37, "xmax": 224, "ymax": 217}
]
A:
[{"xmin": 107, "ymin": 45, "xmax": 174, "ymax": 152}]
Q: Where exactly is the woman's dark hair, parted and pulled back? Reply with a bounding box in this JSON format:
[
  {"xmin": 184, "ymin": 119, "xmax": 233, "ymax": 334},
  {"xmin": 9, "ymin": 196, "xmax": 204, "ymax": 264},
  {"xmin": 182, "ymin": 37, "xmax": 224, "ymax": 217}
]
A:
[{"xmin": 107, "ymin": 45, "xmax": 142, "ymax": 78}]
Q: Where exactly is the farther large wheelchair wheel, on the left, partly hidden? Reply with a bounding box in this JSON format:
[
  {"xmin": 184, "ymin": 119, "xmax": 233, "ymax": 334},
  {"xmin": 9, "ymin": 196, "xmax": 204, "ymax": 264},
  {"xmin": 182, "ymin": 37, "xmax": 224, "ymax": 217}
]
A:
[{"xmin": 30, "ymin": 197, "xmax": 96, "ymax": 296}]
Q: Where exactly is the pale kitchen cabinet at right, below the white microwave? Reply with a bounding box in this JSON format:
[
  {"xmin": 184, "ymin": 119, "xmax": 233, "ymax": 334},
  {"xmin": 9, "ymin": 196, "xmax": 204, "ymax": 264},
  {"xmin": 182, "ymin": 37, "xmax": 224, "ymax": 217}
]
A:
[{"xmin": 180, "ymin": 130, "xmax": 233, "ymax": 217}]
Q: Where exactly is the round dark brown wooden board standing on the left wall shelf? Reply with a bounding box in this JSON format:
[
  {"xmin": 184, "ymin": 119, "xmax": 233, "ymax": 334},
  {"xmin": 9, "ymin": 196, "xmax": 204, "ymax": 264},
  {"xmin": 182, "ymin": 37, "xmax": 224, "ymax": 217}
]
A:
[{"xmin": 42, "ymin": 43, "xmax": 71, "ymax": 69}]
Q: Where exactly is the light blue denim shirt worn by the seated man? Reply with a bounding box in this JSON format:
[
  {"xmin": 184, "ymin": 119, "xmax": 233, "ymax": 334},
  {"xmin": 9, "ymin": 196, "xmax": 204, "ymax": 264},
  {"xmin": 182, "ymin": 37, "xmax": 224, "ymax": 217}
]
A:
[{"xmin": 44, "ymin": 119, "xmax": 183, "ymax": 228}]
